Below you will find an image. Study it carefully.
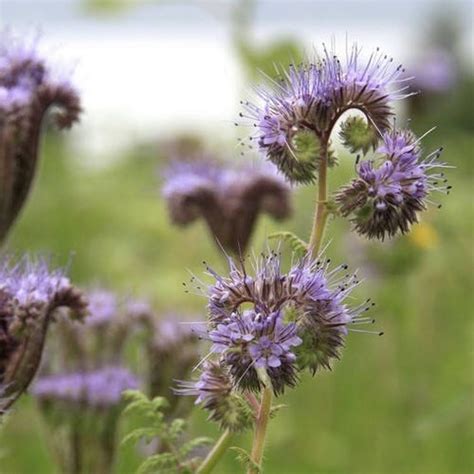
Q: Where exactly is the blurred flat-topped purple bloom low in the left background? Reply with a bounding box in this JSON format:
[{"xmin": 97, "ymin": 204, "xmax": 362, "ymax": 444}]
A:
[{"xmin": 32, "ymin": 367, "xmax": 139, "ymax": 408}]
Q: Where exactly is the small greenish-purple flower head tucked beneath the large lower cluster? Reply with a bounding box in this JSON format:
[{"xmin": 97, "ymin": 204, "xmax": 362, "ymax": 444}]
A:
[{"xmin": 175, "ymin": 361, "xmax": 252, "ymax": 432}]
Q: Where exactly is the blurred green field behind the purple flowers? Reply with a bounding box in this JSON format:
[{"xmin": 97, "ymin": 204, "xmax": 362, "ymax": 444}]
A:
[{"xmin": 0, "ymin": 112, "xmax": 474, "ymax": 474}]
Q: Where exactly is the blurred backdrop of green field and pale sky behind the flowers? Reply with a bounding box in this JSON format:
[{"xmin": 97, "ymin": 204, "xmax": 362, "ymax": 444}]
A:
[{"xmin": 0, "ymin": 0, "xmax": 474, "ymax": 474}]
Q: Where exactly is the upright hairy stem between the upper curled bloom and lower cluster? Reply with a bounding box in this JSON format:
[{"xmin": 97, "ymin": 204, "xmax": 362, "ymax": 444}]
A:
[{"xmin": 308, "ymin": 140, "xmax": 329, "ymax": 256}]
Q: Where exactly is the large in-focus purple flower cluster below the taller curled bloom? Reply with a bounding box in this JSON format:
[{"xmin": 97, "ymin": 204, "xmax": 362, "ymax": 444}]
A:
[{"xmin": 181, "ymin": 253, "xmax": 373, "ymax": 430}]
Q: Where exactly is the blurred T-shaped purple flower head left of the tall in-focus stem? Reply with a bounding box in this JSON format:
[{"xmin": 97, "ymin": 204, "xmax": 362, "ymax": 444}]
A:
[{"xmin": 163, "ymin": 157, "xmax": 291, "ymax": 254}]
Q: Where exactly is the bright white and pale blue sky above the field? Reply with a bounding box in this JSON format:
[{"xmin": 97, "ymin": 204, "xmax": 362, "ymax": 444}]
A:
[{"xmin": 0, "ymin": 0, "xmax": 472, "ymax": 157}]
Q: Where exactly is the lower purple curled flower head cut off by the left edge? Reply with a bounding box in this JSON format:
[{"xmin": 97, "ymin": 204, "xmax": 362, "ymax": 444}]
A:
[{"xmin": 0, "ymin": 257, "xmax": 87, "ymax": 408}]
